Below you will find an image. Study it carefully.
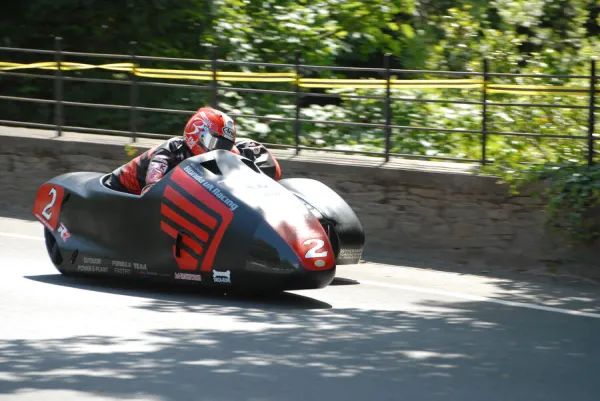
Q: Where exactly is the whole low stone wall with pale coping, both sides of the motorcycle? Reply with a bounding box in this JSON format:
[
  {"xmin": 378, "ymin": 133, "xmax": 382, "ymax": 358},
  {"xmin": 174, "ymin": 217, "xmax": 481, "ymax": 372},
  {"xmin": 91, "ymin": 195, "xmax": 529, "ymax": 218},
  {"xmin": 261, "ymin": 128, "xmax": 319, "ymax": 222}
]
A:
[{"xmin": 0, "ymin": 127, "xmax": 600, "ymax": 276}]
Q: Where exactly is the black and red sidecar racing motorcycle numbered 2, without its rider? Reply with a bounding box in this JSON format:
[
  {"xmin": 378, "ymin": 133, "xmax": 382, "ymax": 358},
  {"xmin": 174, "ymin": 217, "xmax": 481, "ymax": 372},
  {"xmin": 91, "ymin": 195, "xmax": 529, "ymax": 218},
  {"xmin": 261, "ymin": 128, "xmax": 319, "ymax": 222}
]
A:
[{"xmin": 33, "ymin": 150, "xmax": 365, "ymax": 291}]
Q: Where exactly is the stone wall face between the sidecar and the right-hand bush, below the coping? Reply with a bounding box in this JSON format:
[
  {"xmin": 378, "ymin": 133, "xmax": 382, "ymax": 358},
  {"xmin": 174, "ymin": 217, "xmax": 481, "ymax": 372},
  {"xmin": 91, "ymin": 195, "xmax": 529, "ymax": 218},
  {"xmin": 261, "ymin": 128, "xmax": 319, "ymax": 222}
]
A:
[{"xmin": 276, "ymin": 155, "xmax": 567, "ymax": 267}]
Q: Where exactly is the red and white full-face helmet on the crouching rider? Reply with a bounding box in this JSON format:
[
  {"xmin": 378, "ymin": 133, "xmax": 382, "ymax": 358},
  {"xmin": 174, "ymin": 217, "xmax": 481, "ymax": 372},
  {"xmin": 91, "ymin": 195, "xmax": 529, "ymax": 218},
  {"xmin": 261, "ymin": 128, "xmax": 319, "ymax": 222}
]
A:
[{"xmin": 183, "ymin": 107, "xmax": 236, "ymax": 155}]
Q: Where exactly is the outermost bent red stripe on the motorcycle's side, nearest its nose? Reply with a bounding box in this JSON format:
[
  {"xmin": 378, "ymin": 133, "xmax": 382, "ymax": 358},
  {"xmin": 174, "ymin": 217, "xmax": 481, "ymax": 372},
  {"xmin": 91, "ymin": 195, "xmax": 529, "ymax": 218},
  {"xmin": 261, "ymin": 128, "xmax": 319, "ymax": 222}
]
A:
[{"xmin": 171, "ymin": 168, "xmax": 233, "ymax": 271}]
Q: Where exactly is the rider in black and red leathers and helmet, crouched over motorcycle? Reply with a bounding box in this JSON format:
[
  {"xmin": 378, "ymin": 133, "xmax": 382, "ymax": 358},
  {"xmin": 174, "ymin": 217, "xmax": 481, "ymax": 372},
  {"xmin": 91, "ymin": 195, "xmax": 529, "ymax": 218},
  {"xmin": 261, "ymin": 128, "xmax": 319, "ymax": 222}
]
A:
[{"xmin": 106, "ymin": 107, "xmax": 281, "ymax": 195}]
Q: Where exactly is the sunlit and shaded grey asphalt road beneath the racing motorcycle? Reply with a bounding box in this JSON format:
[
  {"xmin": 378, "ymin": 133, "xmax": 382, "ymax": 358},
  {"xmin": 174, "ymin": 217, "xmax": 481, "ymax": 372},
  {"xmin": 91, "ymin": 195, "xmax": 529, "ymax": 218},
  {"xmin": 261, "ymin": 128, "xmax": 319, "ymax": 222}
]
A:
[{"xmin": 0, "ymin": 219, "xmax": 600, "ymax": 401}]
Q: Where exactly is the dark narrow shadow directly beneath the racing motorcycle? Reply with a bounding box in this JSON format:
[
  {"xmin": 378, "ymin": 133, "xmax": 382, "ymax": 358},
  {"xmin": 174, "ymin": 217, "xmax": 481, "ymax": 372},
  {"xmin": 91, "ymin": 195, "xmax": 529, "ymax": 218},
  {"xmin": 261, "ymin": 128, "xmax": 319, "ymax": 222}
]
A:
[{"xmin": 24, "ymin": 274, "xmax": 332, "ymax": 310}]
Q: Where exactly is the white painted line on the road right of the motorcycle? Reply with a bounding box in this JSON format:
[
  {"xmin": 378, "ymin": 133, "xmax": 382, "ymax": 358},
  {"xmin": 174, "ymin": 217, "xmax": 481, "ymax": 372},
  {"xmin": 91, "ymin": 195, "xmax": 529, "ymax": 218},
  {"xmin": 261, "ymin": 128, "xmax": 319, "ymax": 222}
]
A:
[{"xmin": 358, "ymin": 279, "xmax": 600, "ymax": 319}]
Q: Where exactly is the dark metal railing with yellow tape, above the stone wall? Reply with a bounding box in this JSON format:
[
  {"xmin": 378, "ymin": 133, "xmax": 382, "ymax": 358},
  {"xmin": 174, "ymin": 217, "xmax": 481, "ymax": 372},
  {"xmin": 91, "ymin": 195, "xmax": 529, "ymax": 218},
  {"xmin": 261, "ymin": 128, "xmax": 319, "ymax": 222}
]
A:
[{"xmin": 0, "ymin": 38, "xmax": 598, "ymax": 165}]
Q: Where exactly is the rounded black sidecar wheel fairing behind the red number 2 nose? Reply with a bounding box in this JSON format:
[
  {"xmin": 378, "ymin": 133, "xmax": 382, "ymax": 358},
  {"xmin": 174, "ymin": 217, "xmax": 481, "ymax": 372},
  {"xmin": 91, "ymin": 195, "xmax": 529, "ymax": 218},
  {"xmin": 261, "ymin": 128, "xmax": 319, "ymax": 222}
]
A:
[{"xmin": 279, "ymin": 178, "xmax": 365, "ymax": 265}]
